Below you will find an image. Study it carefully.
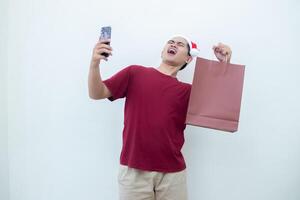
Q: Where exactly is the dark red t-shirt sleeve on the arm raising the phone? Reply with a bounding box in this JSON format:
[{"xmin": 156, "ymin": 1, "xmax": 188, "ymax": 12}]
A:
[{"xmin": 103, "ymin": 66, "xmax": 131, "ymax": 101}]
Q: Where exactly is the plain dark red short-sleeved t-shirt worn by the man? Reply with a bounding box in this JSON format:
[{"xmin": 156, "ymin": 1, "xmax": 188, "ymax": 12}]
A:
[{"xmin": 103, "ymin": 65, "xmax": 191, "ymax": 172}]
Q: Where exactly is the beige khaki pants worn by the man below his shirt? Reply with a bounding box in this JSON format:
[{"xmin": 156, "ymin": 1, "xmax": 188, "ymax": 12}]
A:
[{"xmin": 118, "ymin": 165, "xmax": 187, "ymax": 200}]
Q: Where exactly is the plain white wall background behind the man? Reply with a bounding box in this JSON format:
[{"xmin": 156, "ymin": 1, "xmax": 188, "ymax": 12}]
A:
[{"xmin": 0, "ymin": 0, "xmax": 300, "ymax": 200}]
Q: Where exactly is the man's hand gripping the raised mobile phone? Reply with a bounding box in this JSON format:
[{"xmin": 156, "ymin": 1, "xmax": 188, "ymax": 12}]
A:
[{"xmin": 92, "ymin": 39, "xmax": 112, "ymax": 63}]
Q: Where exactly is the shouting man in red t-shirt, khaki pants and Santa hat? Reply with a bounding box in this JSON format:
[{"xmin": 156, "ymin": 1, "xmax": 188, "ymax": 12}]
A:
[{"xmin": 88, "ymin": 36, "xmax": 231, "ymax": 200}]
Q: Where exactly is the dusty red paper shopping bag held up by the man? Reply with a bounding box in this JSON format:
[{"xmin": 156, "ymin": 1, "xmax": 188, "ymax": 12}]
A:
[{"xmin": 186, "ymin": 57, "xmax": 245, "ymax": 132}]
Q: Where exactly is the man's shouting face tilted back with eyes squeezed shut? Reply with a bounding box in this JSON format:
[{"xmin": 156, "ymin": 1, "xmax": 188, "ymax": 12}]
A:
[{"xmin": 161, "ymin": 37, "xmax": 192, "ymax": 67}]
